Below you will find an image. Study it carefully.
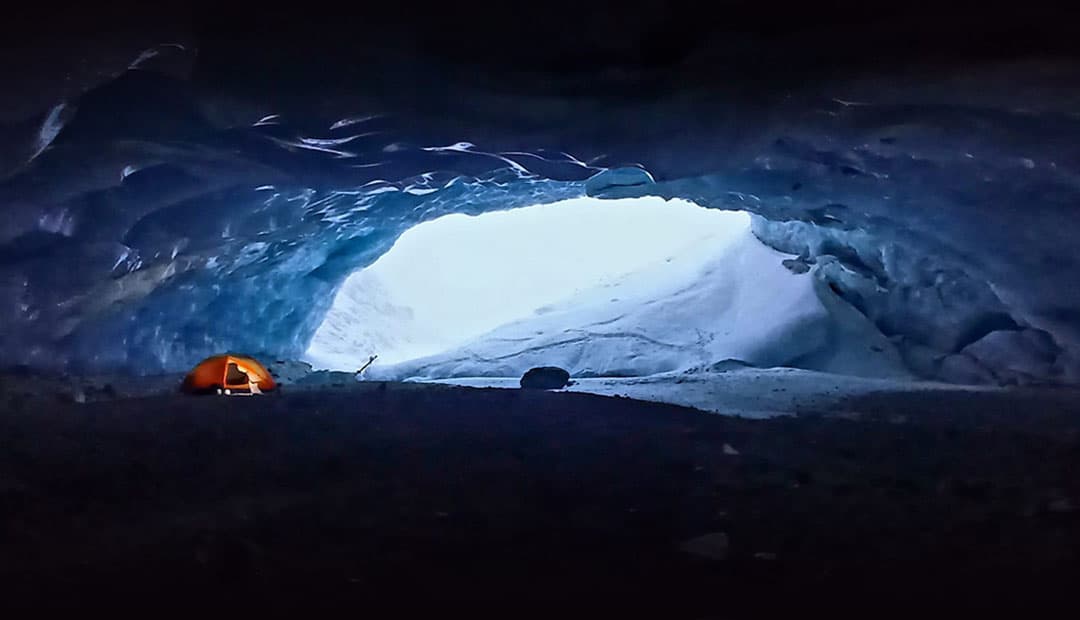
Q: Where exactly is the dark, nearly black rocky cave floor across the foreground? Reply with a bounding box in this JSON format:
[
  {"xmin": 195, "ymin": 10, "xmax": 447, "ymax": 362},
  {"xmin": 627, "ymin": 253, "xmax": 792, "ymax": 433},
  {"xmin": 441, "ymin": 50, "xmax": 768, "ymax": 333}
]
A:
[{"xmin": 0, "ymin": 383, "xmax": 1080, "ymax": 618}]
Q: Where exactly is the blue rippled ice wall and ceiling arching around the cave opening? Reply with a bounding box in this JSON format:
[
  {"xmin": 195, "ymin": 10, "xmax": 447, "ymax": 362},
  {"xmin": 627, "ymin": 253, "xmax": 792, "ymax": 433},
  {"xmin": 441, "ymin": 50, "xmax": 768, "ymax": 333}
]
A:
[{"xmin": 0, "ymin": 51, "xmax": 1080, "ymax": 382}]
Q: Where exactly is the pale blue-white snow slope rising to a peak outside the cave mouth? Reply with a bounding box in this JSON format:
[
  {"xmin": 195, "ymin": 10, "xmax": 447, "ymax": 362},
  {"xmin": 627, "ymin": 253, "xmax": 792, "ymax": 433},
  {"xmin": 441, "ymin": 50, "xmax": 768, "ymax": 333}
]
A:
[{"xmin": 367, "ymin": 204, "xmax": 909, "ymax": 379}]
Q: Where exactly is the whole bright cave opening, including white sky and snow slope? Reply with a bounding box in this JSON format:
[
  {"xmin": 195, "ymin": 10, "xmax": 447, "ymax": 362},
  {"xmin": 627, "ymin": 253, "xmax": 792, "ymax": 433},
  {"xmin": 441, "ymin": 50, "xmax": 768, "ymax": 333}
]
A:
[{"xmin": 306, "ymin": 197, "xmax": 906, "ymax": 379}]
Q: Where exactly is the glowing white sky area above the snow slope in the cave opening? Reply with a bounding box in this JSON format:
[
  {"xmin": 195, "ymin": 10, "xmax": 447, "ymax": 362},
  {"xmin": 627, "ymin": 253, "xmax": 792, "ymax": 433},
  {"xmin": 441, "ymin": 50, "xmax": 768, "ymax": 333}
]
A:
[{"xmin": 306, "ymin": 197, "xmax": 750, "ymax": 370}]
